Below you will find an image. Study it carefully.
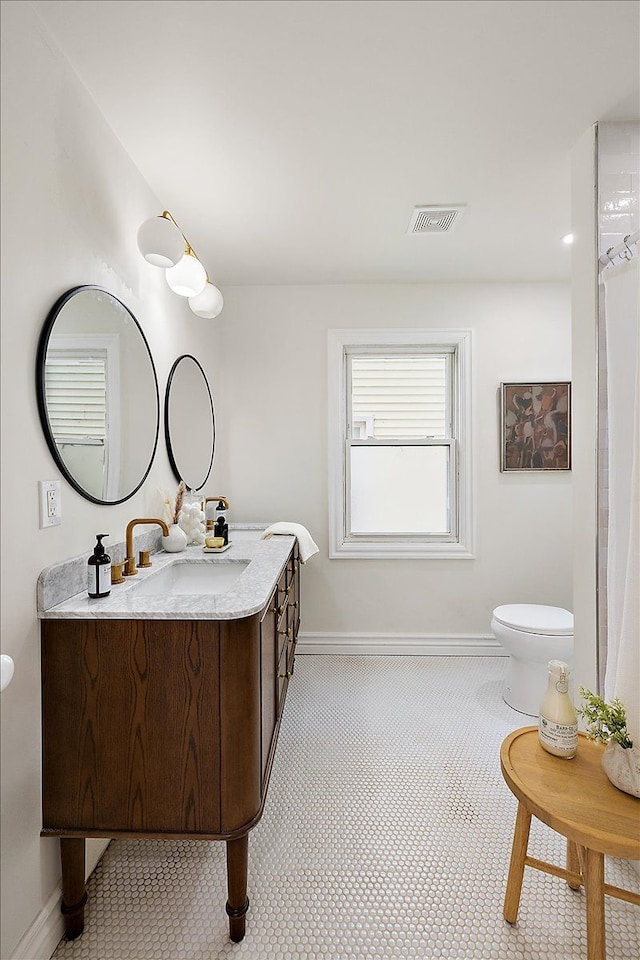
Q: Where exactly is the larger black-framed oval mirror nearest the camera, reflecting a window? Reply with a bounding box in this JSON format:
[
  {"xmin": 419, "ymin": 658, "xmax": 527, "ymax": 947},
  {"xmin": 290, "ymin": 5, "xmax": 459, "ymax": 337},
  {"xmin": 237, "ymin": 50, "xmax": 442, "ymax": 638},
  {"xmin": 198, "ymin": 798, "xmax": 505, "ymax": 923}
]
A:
[{"xmin": 36, "ymin": 284, "xmax": 160, "ymax": 504}]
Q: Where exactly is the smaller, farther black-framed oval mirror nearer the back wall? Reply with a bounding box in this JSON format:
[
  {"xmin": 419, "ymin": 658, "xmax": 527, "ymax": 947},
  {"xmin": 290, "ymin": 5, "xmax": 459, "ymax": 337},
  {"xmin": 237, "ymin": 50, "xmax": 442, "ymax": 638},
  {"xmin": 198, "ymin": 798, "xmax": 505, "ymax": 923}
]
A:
[{"xmin": 164, "ymin": 353, "xmax": 216, "ymax": 490}]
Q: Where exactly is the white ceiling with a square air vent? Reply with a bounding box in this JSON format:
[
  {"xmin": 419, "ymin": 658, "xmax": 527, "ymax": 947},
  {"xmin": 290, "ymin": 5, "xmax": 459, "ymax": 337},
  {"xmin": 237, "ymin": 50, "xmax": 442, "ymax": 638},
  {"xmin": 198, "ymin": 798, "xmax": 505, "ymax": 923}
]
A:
[{"xmin": 31, "ymin": 0, "xmax": 640, "ymax": 291}]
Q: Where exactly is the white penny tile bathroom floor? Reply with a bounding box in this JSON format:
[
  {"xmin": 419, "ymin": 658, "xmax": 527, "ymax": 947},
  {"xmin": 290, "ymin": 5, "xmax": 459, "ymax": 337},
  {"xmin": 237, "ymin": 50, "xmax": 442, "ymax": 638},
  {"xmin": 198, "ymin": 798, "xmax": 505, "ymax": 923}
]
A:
[{"xmin": 54, "ymin": 655, "xmax": 640, "ymax": 960}]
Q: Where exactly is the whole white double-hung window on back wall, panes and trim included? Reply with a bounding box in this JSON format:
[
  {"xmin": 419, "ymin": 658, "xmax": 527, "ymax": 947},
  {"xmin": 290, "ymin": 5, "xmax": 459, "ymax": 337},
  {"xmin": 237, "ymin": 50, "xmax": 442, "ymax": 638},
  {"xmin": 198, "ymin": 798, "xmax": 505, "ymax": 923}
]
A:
[{"xmin": 329, "ymin": 330, "xmax": 472, "ymax": 558}]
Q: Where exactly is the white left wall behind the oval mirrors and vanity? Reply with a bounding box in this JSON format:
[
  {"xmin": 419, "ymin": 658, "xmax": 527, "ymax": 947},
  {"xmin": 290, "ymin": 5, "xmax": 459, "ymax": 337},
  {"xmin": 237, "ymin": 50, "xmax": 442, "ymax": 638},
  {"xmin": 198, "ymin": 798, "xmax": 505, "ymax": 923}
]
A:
[{"xmin": 1, "ymin": 3, "xmax": 225, "ymax": 960}]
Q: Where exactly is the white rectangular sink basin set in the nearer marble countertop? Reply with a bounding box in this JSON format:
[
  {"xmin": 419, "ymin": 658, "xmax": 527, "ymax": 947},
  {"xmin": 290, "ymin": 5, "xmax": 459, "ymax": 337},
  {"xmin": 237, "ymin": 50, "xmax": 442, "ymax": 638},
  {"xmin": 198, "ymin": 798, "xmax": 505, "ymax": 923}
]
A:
[{"xmin": 132, "ymin": 560, "xmax": 251, "ymax": 597}]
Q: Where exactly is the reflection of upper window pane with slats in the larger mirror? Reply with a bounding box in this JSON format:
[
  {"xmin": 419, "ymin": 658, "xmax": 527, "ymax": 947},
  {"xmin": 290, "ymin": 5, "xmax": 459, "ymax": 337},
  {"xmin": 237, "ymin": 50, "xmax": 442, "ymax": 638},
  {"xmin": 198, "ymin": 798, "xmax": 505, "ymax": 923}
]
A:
[{"xmin": 45, "ymin": 356, "xmax": 107, "ymax": 444}]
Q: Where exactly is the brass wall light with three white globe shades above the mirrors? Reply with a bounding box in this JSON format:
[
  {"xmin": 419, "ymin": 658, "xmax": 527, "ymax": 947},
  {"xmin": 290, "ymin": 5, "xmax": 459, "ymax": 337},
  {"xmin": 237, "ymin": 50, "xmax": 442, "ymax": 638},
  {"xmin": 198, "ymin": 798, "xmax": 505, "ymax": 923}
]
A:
[{"xmin": 138, "ymin": 210, "xmax": 224, "ymax": 320}]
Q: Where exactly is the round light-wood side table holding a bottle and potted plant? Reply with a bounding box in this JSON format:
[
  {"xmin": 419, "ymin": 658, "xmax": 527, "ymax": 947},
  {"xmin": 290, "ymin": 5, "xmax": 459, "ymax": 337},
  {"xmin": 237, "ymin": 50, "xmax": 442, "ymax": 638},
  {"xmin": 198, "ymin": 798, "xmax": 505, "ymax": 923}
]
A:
[{"xmin": 500, "ymin": 727, "xmax": 640, "ymax": 960}]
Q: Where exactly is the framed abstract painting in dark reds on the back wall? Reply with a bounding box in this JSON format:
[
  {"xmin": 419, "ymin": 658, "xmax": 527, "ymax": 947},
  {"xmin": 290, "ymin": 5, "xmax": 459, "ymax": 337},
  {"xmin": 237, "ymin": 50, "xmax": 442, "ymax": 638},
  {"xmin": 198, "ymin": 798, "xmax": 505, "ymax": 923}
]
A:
[{"xmin": 500, "ymin": 380, "xmax": 571, "ymax": 473}]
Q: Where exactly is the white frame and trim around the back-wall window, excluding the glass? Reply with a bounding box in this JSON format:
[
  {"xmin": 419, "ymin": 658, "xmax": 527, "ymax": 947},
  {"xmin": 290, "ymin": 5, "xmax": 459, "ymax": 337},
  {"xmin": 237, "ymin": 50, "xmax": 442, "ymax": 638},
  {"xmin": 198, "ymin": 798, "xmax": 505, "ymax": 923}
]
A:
[{"xmin": 328, "ymin": 329, "xmax": 474, "ymax": 560}]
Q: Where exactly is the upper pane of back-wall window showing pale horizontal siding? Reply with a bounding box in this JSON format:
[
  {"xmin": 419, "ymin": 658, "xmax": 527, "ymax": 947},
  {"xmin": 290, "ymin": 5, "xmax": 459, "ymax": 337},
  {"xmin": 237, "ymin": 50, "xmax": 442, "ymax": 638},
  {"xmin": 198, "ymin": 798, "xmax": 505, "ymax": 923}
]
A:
[{"xmin": 351, "ymin": 355, "xmax": 448, "ymax": 440}]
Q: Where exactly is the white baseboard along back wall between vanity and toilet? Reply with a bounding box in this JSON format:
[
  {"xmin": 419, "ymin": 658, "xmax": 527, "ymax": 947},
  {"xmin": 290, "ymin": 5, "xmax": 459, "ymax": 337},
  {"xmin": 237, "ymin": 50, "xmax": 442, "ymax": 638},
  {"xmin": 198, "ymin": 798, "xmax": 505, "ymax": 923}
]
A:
[{"xmin": 297, "ymin": 632, "xmax": 507, "ymax": 657}]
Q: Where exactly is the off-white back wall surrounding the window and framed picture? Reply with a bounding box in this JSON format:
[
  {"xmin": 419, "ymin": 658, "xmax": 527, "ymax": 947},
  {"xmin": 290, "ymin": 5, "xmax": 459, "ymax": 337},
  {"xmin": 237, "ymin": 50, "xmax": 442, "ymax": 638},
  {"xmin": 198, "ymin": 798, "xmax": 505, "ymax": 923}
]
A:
[{"xmin": 214, "ymin": 284, "xmax": 572, "ymax": 640}]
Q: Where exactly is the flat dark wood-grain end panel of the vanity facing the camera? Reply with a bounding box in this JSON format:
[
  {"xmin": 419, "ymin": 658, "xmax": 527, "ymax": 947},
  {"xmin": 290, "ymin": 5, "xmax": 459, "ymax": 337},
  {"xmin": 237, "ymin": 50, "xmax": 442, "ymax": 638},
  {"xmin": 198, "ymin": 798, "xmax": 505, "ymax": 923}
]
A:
[{"xmin": 42, "ymin": 620, "xmax": 220, "ymax": 833}]
